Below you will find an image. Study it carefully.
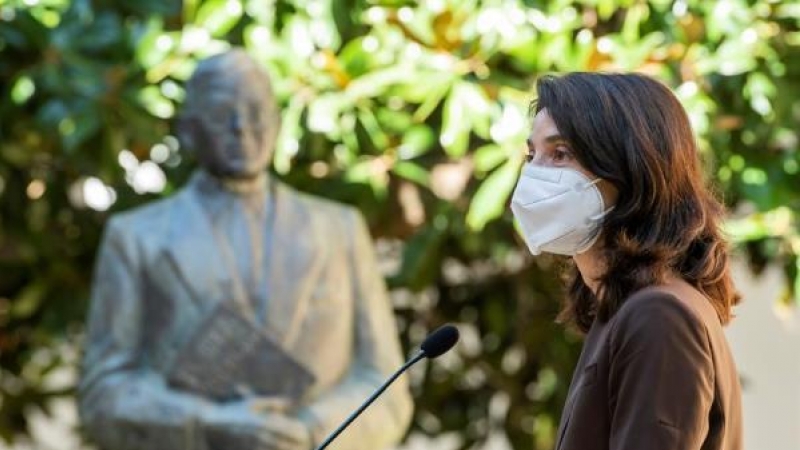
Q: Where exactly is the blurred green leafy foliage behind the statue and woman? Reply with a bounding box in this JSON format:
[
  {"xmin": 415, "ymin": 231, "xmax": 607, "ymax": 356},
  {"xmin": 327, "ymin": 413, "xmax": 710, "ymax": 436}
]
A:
[{"xmin": 0, "ymin": 0, "xmax": 800, "ymax": 449}]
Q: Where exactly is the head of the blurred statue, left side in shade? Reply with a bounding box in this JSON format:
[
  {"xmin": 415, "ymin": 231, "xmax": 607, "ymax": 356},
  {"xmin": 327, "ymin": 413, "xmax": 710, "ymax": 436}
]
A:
[{"xmin": 178, "ymin": 49, "xmax": 280, "ymax": 178}]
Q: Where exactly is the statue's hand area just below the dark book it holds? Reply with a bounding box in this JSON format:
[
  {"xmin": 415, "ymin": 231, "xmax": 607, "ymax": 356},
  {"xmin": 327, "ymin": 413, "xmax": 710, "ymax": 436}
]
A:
[{"xmin": 200, "ymin": 402, "xmax": 311, "ymax": 450}]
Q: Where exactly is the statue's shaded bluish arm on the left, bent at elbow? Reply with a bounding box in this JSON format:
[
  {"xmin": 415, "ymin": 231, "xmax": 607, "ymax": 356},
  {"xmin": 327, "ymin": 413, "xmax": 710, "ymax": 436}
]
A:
[{"xmin": 78, "ymin": 219, "xmax": 208, "ymax": 450}]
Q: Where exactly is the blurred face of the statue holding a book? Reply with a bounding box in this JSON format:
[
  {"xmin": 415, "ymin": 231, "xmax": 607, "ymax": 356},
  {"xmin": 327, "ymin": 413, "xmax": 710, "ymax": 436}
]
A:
[{"xmin": 184, "ymin": 77, "xmax": 278, "ymax": 178}]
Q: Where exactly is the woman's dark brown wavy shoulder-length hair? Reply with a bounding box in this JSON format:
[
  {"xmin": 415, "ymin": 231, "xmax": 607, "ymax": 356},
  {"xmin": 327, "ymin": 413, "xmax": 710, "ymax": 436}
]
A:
[{"xmin": 531, "ymin": 73, "xmax": 740, "ymax": 332}]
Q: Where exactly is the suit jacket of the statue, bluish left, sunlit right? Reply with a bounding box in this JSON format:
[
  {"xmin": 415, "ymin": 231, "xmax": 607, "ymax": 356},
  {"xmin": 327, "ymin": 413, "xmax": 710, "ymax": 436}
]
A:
[{"xmin": 79, "ymin": 175, "xmax": 412, "ymax": 450}]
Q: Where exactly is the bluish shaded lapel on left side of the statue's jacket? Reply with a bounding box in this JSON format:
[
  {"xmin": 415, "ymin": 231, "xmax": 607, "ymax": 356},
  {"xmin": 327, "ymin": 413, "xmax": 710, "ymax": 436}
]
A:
[{"xmin": 165, "ymin": 186, "xmax": 232, "ymax": 306}]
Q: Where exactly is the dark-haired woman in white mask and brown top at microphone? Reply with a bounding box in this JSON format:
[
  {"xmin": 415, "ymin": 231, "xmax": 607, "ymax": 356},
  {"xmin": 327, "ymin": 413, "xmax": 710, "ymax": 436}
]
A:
[{"xmin": 512, "ymin": 73, "xmax": 742, "ymax": 450}]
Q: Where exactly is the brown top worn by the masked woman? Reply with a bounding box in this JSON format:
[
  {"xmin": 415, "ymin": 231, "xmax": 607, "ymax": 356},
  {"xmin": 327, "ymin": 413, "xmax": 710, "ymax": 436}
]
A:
[{"xmin": 556, "ymin": 282, "xmax": 743, "ymax": 450}]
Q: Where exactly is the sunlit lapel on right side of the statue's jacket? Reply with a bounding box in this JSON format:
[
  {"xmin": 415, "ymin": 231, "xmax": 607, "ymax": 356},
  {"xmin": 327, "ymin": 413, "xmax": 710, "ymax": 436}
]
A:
[{"xmin": 265, "ymin": 181, "xmax": 325, "ymax": 347}]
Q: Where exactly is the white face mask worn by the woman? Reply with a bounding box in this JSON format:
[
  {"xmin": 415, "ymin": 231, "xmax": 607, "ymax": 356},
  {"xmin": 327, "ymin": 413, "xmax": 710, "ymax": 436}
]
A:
[{"xmin": 511, "ymin": 164, "xmax": 610, "ymax": 256}]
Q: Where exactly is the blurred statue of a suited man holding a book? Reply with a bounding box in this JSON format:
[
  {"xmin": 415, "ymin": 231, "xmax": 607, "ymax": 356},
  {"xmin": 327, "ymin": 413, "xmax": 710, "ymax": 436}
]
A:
[{"xmin": 79, "ymin": 49, "xmax": 412, "ymax": 450}]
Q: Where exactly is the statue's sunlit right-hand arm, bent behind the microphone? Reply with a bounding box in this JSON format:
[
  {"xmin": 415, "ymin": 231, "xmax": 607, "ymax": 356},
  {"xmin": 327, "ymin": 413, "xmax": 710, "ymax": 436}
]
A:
[{"xmin": 300, "ymin": 212, "xmax": 413, "ymax": 450}]
